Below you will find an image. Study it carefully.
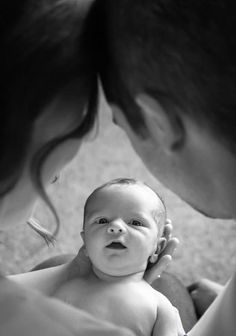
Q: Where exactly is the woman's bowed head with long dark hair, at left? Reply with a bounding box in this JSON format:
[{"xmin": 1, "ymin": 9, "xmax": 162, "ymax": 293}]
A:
[{"xmin": 0, "ymin": 0, "xmax": 97, "ymax": 228}]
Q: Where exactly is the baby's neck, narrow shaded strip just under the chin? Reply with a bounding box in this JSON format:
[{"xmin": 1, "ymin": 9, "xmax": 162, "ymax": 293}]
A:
[{"xmin": 92, "ymin": 266, "xmax": 144, "ymax": 282}]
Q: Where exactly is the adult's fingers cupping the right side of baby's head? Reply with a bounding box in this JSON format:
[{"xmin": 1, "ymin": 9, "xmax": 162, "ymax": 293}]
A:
[{"xmin": 144, "ymin": 219, "xmax": 179, "ymax": 284}]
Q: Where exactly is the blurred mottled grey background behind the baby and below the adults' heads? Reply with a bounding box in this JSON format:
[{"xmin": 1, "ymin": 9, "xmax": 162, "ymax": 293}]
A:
[{"xmin": 0, "ymin": 93, "xmax": 236, "ymax": 284}]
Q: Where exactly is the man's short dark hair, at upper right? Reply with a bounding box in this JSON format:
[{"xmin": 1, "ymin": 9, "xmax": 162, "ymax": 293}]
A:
[{"xmin": 97, "ymin": 0, "xmax": 236, "ymax": 152}]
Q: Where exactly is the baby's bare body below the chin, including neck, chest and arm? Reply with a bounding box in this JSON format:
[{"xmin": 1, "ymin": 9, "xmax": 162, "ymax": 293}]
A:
[{"xmin": 54, "ymin": 266, "xmax": 176, "ymax": 335}]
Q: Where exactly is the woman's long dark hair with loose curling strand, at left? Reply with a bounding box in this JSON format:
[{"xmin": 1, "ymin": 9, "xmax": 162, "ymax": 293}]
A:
[{"xmin": 0, "ymin": 0, "xmax": 98, "ymax": 242}]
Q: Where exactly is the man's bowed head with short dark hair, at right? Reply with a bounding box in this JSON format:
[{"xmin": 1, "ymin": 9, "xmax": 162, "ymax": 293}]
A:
[{"xmin": 100, "ymin": 0, "xmax": 236, "ymax": 218}]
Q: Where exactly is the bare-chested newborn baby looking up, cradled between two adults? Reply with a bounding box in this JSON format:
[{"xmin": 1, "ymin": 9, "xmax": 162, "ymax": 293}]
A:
[{"xmin": 55, "ymin": 179, "xmax": 181, "ymax": 336}]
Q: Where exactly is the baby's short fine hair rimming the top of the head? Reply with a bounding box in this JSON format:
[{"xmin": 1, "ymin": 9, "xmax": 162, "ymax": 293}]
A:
[{"xmin": 83, "ymin": 177, "xmax": 167, "ymax": 229}]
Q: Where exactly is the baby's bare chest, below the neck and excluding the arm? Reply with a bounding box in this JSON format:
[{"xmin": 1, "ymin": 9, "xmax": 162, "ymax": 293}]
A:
[{"xmin": 55, "ymin": 283, "xmax": 157, "ymax": 336}]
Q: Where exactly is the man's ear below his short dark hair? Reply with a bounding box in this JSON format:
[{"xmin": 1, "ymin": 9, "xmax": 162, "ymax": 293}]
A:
[{"xmin": 135, "ymin": 93, "xmax": 185, "ymax": 151}]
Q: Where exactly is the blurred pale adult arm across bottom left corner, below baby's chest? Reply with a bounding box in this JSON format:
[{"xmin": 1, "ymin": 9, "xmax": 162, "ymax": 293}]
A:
[{"xmin": 0, "ymin": 278, "xmax": 134, "ymax": 336}]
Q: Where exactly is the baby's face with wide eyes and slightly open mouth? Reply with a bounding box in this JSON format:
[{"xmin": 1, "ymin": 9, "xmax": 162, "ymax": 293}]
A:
[{"xmin": 81, "ymin": 185, "xmax": 164, "ymax": 276}]
